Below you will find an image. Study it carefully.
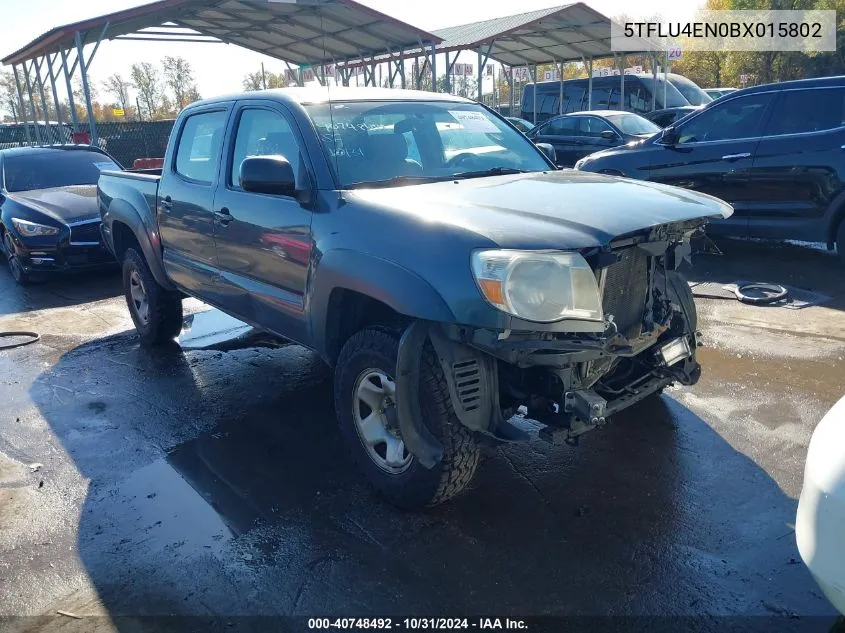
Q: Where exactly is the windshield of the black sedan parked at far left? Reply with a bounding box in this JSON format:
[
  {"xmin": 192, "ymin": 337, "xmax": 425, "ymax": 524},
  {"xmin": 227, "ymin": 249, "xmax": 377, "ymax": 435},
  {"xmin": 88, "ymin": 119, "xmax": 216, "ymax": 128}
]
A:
[{"xmin": 2, "ymin": 149, "xmax": 120, "ymax": 192}]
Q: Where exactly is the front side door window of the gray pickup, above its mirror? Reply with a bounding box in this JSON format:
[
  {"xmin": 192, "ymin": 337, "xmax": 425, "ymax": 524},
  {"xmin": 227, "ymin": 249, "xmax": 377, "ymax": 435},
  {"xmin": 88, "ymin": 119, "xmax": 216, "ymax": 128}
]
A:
[{"xmin": 230, "ymin": 108, "xmax": 302, "ymax": 187}]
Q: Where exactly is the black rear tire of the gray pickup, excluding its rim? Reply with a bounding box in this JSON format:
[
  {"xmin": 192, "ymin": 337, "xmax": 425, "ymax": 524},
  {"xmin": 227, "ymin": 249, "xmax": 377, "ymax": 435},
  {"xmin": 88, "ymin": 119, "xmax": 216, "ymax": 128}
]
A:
[{"xmin": 123, "ymin": 248, "xmax": 182, "ymax": 347}]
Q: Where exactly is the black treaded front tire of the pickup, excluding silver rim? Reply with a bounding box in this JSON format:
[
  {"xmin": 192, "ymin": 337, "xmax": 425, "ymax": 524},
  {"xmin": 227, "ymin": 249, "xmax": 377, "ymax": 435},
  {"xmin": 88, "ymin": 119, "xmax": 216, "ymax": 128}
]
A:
[{"xmin": 334, "ymin": 328, "xmax": 479, "ymax": 510}]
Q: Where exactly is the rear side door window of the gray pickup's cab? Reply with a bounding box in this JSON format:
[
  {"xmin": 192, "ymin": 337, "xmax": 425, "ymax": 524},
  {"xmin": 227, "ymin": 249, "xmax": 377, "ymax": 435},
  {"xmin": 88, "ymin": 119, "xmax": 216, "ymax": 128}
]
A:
[{"xmin": 176, "ymin": 110, "xmax": 227, "ymax": 184}]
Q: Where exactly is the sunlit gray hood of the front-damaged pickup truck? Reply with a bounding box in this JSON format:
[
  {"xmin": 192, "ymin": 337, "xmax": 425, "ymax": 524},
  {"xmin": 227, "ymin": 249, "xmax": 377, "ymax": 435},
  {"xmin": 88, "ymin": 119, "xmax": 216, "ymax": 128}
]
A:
[{"xmin": 347, "ymin": 170, "xmax": 733, "ymax": 249}]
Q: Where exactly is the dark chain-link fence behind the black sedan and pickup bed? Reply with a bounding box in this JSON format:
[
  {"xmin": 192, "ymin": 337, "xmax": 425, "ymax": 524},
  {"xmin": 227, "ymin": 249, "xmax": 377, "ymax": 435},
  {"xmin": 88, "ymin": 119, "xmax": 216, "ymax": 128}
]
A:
[{"xmin": 0, "ymin": 120, "xmax": 174, "ymax": 167}]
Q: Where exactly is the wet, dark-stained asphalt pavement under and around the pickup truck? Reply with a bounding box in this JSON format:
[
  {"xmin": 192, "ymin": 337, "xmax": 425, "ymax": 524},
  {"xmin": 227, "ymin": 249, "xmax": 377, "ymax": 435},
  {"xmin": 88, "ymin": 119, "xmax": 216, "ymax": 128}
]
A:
[{"xmin": 0, "ymin": 242, "xmax": 845, "ymax": 631}]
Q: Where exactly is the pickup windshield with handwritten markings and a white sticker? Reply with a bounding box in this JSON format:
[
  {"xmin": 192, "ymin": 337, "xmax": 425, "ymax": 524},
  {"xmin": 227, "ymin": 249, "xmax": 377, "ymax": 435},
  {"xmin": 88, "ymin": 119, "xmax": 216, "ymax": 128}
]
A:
[{"xmin": 306, "ymin": 101, "xmax": 551, "ymax": 189}]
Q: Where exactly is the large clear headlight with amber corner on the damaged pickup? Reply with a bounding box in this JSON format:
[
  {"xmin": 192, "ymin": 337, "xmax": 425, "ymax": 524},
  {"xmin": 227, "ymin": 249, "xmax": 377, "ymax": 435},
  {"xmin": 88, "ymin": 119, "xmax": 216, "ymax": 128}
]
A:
[{"xmin": 472, "ymin": 250, "xmax": 603, "ymax": 323}]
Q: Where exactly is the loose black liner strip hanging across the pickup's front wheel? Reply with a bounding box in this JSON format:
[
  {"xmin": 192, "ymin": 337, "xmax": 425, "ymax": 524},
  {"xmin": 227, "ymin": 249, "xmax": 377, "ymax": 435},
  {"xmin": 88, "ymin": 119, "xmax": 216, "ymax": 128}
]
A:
[{"xmin": 396, "ymin": 321, "xmax": 443, "ymax": 470}]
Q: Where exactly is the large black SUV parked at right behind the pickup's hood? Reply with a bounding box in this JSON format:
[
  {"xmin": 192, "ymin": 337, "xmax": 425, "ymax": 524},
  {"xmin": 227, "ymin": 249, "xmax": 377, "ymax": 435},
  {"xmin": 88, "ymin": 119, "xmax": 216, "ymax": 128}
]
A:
[{"xmin": 575, "ymin": 77, "xmax": 845, "ymax": 259}]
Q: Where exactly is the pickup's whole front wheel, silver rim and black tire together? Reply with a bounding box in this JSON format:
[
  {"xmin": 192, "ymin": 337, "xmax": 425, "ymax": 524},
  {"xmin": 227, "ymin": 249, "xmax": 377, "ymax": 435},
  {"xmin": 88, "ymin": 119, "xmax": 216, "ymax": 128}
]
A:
[{"xmin": 334, "ymin": 329, "xmax": 479, "ymax": 510}]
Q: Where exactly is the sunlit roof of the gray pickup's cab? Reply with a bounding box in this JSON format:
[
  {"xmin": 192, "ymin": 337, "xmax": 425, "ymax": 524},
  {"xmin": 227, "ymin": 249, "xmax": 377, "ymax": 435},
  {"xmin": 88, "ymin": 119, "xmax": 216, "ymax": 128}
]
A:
[{"xmin": 187, "ymin": 86, "xmax": 475, "ymax": 105}]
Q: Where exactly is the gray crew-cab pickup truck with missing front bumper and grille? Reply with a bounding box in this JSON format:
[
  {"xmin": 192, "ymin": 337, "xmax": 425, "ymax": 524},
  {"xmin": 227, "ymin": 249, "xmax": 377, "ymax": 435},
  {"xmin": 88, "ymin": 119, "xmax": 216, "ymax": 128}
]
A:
[{"xmin": 98, "ymin": 88, "xmax": 731, "ymax": 508}]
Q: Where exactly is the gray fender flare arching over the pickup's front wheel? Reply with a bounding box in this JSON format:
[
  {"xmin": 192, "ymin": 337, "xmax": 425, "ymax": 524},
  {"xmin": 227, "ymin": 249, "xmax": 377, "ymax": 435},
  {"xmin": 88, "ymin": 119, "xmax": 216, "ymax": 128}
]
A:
[{"xmin": 308, "ymin": 249, "xmax": 455, "ymax": 358}]
